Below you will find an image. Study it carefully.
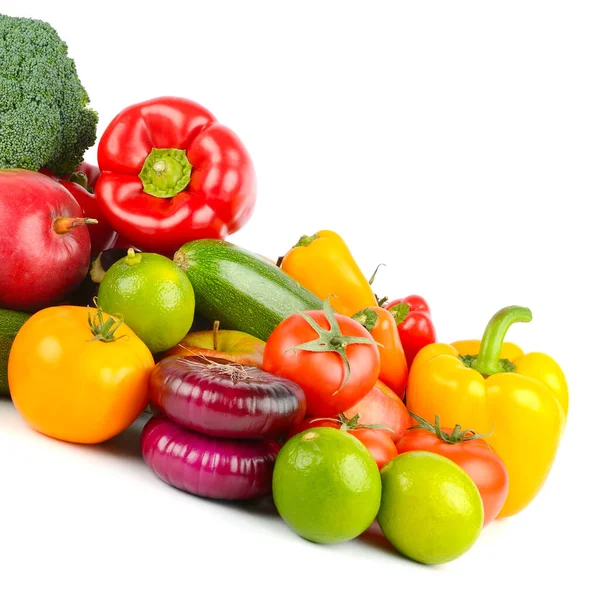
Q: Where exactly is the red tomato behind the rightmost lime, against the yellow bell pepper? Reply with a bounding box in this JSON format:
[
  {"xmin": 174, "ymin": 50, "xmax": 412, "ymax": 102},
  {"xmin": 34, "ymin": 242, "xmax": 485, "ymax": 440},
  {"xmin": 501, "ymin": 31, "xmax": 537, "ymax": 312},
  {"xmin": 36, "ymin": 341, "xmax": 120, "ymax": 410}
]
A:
[{"xmin": 396, "ymin": 429, "xmax": 508, "ymax": 527}]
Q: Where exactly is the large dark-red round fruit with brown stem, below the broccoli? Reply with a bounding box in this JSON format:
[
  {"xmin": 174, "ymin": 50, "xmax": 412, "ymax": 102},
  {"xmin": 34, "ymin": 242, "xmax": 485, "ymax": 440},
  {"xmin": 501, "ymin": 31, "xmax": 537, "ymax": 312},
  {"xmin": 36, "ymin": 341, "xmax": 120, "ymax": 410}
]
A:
[{"xmin": 0, "ymin": 169, "xmax": 95, "ymax": 312}]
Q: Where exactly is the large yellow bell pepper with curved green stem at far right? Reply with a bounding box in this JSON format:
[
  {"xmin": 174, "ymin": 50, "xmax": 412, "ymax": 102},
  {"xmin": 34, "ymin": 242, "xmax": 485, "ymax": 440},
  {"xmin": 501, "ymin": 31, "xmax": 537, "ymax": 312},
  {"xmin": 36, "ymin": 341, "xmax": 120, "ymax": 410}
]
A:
[{"xmin": 406, "ymin": 306, "xmax": 569, "ymax": 517}]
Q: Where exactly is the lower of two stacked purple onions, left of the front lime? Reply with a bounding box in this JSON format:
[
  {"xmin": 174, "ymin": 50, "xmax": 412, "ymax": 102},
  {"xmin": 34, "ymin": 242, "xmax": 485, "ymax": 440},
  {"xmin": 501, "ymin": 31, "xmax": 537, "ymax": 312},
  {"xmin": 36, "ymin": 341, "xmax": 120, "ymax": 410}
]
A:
[{"xmin": 141, "ymin": 415, "xmax": 280, "ymax": 500}]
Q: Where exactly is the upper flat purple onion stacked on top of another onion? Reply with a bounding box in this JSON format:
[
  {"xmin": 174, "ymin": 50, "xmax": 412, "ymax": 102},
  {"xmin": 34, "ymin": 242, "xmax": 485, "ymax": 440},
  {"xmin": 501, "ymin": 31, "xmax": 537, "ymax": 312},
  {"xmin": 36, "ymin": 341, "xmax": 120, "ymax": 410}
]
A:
[{"xmin": 149, "ymin": 356, "xmax": 306, "ymax": 439}]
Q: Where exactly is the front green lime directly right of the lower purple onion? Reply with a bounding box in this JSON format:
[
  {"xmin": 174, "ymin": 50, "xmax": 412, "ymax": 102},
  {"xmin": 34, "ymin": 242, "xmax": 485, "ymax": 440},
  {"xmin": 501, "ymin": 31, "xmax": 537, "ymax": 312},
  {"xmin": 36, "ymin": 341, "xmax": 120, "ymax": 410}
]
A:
[{"xmin": 273, "ymin": 427, "xmax": 381, "ymax": 544}]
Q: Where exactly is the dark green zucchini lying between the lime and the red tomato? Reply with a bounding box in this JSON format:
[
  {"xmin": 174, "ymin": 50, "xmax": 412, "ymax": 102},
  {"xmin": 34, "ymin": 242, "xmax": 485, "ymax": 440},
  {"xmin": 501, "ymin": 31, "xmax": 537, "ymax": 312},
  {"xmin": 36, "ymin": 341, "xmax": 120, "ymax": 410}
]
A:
[{"xmin": 173, "ymin": 239, "xmax": 323, "ymax": 341}]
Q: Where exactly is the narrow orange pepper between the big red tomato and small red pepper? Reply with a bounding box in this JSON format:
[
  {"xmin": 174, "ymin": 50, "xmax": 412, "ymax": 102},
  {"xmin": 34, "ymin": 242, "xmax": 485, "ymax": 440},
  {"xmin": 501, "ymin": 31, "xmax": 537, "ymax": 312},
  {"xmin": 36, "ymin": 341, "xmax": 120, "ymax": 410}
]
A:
[{"xmin": 354, "ymin": 306, "xmax": 408, "ymax": 398}]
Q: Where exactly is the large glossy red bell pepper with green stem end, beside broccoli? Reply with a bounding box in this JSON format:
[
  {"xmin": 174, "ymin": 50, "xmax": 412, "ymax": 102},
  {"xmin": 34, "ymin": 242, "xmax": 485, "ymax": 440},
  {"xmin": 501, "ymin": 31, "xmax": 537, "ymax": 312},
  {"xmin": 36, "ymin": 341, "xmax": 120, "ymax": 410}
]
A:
[{"xmin": 96, "ymin": 96, "xmax": 256, "ymax": 256}]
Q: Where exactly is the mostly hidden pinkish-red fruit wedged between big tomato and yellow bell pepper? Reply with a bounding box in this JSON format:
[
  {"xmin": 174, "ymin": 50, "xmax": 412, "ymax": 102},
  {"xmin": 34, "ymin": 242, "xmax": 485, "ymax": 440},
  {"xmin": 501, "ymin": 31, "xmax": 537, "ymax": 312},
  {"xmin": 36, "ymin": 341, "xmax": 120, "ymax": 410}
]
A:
[{"xmin": 344, "ymin": 381, "xmax": 412, "ymax": 442}]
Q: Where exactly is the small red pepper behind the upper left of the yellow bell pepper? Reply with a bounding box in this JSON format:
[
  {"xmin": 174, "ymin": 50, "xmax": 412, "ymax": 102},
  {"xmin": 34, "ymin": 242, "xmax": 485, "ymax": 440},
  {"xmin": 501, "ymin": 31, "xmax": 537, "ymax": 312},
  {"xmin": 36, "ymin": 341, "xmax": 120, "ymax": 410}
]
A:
[{"xmin": 385, "ymin": 294, "xmax": 437, "ymax": 369}]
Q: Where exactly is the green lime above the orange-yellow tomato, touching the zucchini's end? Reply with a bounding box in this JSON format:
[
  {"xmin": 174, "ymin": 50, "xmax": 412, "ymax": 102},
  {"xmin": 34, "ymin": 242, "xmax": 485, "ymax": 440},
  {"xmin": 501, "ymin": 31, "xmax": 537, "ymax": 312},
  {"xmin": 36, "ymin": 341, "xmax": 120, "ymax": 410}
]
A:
[{"xmin": 98, "ymin": 250, "xmax": 196, "ymax": 354}]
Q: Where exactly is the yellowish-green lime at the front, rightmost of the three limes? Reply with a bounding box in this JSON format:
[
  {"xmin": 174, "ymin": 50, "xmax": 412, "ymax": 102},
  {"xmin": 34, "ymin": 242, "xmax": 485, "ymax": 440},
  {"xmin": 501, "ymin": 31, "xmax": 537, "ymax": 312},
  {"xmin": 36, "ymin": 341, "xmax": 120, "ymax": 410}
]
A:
[{"xmin": 377, "ymin": 451, "xmax": 483, "ymax": 565}]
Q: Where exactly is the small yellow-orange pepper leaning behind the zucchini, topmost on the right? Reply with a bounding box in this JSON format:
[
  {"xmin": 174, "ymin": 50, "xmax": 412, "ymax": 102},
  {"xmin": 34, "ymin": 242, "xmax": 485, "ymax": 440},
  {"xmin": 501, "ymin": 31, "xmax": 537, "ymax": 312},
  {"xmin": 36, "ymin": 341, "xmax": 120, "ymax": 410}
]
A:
[{"xmin": 281, "ymin": 230, "xmax": 377, "ymax": 317}]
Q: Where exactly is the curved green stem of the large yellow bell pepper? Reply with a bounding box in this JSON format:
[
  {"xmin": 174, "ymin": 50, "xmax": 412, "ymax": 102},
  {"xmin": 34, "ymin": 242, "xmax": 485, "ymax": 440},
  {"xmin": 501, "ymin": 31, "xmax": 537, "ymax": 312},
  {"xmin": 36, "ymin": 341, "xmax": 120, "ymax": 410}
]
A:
[{"xmin": 471, "ymin": 306, "xmax": 532, "ymax": 375}]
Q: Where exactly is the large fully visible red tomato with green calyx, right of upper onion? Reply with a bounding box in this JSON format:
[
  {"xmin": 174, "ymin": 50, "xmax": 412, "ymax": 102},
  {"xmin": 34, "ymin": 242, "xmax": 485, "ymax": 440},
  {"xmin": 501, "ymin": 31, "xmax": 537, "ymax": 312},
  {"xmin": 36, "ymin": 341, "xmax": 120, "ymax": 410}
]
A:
[{"xmin": 263, "ymin": 310, "xmax": 380, "ymax": 417}]
